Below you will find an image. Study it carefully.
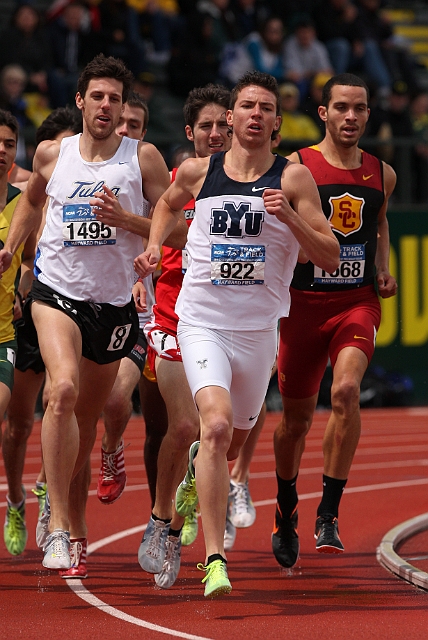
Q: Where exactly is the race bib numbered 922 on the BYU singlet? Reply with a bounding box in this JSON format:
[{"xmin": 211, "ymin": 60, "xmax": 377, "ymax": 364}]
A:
[{"xmin": 211, "ymin": 244, "xmax": 266, "ymax": 286}]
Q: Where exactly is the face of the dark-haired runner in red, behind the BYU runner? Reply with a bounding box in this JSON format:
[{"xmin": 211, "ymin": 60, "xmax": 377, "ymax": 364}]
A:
[{"xmin": 185, "ymin": 104, "xmax": 230, "ymax": 158}]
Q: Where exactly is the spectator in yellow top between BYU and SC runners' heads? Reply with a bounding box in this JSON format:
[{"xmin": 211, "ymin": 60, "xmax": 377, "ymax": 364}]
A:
[{"xmin": 279, "ymin": 82, "xmax": 321, "ymax": 156}]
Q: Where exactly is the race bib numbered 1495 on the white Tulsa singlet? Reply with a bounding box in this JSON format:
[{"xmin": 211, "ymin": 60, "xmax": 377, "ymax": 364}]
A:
[{"xmin": 62, "ymin": 204, "xmax": 116, "ymax": 247}]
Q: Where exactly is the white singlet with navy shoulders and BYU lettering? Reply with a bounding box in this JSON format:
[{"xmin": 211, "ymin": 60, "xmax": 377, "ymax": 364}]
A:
[{"xmin": 175, "ymin": 152, "xmax": 299, "ymax": 331}]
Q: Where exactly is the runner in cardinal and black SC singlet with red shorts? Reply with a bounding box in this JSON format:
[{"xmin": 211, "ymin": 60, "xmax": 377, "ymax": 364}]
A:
[{"xmin": 272, "ymin": 74, "xmax": 397, "ymax": 567}]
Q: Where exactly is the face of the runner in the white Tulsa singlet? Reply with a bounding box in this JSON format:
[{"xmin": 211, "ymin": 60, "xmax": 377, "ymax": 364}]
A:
[{"xmin": 76, "ymin": 78, "xmax": 123, "ymax": 140}]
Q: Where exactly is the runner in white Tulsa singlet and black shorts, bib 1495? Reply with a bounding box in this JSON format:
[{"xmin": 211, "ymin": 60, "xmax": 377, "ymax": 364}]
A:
[{"xmin": 0, "ymin": 54, "xmax": 169, "ymax": 570}]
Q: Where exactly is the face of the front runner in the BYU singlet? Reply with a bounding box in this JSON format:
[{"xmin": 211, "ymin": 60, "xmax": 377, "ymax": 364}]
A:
[{"xmin": 227, "ymin": 85, "xmax": 281, "ymax": 147}]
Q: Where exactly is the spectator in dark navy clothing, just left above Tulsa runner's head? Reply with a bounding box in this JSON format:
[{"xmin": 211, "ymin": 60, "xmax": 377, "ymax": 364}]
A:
[{"xmin": 48, "ymin": 0, "xmax": 101, "ymax": 108}]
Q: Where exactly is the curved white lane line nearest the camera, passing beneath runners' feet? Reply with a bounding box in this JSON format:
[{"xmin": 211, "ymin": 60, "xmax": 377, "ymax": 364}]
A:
[{"xmin": 66, "ymin": 478, "xmax": 428, "ymax": 640}]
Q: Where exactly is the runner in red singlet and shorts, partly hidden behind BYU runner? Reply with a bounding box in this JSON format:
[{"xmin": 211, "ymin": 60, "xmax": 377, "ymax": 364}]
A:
[{"xmin": 138, "ymin": 85, "xmax": 230, "ymax": 588}]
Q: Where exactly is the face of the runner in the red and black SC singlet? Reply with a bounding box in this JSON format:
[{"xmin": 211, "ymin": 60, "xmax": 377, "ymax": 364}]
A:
[{"xmin": 319, "ymin": 85, "xmax": 370, "ymax": 147}]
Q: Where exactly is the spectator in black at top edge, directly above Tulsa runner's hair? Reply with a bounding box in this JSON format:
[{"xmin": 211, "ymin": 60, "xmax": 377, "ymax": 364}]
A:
[{"xmin": 98, "ymin": 0, "xmax": 146, "ymax": 76}]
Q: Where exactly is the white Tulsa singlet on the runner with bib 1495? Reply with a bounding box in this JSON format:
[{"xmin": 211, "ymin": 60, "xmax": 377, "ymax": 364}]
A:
[{"xmin": 34, "ymin": 134, "xmax": 150, "ymax": 306}]
